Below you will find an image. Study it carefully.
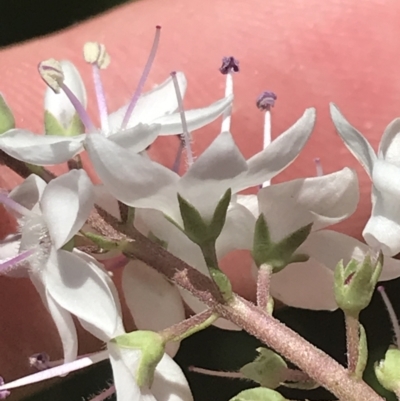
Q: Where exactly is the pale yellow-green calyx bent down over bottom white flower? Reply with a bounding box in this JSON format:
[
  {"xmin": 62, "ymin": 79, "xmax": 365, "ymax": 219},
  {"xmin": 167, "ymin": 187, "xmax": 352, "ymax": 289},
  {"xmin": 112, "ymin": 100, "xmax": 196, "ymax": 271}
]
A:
[{"xmin": 111, "ymin": 330, "xmax": 165, "ymax": 387}]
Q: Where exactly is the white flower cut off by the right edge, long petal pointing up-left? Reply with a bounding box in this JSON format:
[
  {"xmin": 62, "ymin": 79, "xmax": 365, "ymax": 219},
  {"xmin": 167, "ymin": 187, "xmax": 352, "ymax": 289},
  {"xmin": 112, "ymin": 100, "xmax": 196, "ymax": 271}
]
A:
[{"xmin": 330, "ymin": 104, "xmax": 400, "ymax": 256}]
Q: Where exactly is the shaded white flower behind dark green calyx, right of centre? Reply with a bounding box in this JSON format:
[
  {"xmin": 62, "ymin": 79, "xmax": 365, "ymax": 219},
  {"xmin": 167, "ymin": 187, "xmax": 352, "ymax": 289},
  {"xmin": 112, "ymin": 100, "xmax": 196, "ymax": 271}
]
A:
[{"xmin": 237, "ymin": 168, "xmax": 400, "ymax": 310}]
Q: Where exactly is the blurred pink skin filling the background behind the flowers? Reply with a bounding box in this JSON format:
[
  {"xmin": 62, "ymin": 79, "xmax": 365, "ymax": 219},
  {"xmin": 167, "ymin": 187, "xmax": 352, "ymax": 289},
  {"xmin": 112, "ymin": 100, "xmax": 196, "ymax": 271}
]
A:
[{"xmin": 0, "ymin": 0, "xmax": 400, "ymax": 401}]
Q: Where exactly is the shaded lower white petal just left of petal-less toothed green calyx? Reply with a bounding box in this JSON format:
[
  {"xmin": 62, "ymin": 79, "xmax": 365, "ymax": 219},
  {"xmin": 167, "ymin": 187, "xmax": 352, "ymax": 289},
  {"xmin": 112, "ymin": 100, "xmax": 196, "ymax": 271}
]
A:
[{"xmin": 271, "ymin": 258, "xmax": 337, "ymax": 310}]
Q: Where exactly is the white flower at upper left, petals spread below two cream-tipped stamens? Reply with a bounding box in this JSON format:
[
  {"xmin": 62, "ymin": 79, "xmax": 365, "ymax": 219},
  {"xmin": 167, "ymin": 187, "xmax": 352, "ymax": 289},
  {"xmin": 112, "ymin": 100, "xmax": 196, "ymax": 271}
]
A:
[{"xmin": 0, "ymin": 62, "xmax": 233, "ymax": 166}]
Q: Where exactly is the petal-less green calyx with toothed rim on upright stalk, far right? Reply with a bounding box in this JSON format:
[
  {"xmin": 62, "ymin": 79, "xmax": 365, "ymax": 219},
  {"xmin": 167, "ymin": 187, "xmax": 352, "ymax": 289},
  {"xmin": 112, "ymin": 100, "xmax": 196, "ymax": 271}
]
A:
[{"xmin": 334, "ymin": 253, "xmax": 383, "ymax": 317}]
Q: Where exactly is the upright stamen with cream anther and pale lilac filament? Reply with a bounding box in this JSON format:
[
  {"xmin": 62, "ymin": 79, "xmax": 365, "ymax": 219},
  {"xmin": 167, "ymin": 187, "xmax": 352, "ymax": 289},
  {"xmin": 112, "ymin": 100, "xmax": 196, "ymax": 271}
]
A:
[{"xmin": 83, "ymin": 42, "xmax": 110, "ymax": 132}]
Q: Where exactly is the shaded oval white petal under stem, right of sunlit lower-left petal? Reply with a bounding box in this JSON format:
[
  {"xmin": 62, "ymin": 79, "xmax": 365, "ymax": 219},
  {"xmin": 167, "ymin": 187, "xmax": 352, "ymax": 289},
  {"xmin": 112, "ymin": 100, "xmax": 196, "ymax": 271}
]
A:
[{"xmin": 122, "ymin": 260, "xmax": 185, "ymax": 356}]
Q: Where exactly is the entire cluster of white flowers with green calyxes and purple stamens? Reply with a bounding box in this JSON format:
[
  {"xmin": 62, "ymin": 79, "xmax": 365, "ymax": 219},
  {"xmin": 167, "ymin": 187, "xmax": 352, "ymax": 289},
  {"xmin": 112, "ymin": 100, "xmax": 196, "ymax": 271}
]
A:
[{"xmin": 0, "ymin": 27, "xmax": 400, "ymax": 401}]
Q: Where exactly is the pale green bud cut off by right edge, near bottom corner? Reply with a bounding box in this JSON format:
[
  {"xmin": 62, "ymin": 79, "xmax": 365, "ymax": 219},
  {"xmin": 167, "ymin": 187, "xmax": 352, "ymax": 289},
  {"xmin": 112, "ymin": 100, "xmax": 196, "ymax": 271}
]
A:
[{"xmin": 374, "ymin": 347, "xmax": 400, "ymax": 393}]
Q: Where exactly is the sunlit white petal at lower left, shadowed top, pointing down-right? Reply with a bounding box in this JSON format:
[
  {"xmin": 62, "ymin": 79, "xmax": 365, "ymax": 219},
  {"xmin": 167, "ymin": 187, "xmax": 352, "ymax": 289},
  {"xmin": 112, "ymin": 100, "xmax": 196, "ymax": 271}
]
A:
[{"xmin": 43, "ymin": 249, "xmax": 121, "ymax": 341}]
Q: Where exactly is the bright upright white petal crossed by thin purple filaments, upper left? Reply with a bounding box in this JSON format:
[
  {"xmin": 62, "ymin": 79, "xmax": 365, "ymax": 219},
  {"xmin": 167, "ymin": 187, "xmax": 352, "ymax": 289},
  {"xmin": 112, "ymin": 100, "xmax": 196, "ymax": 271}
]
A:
[{"xmin": 108, "ymin": 72, "xmax": 187, "ymax": 130}]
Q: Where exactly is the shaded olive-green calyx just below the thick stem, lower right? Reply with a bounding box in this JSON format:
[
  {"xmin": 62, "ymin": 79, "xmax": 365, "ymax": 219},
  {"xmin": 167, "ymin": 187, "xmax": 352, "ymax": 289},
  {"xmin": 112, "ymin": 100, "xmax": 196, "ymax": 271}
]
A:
[{"xmin": 240, "ymin": 347, "xmax": 287, "ymax": 389}]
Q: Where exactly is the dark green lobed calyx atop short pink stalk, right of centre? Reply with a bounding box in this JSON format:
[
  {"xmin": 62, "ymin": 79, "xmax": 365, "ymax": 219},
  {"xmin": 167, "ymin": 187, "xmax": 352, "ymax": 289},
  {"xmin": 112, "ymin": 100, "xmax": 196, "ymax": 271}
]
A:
[{"xmin": 252, "ymin": 214, "xmax": 312, "ymax": 273}]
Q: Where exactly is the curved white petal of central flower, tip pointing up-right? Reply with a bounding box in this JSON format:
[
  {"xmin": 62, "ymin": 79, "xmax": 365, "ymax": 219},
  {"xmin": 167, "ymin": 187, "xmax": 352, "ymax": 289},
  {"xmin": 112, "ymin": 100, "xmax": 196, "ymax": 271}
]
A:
[{"xmin": 232, "ymin": 108, "xmax": 316, "ymax": 192}]
